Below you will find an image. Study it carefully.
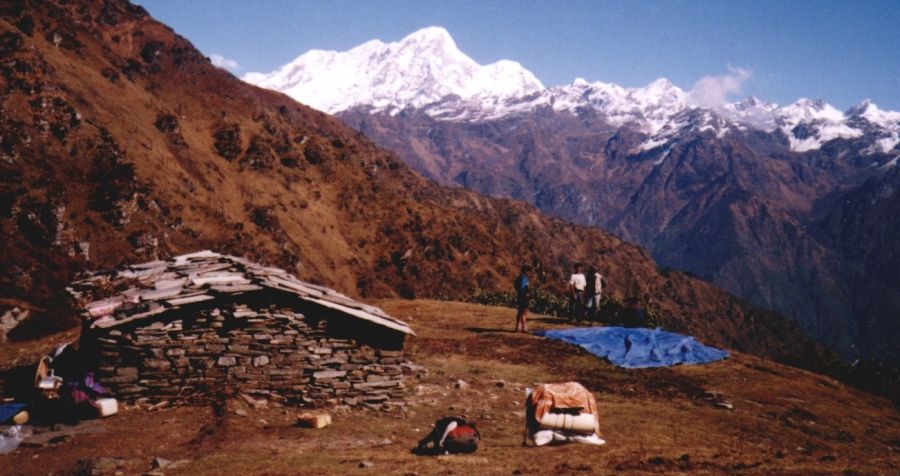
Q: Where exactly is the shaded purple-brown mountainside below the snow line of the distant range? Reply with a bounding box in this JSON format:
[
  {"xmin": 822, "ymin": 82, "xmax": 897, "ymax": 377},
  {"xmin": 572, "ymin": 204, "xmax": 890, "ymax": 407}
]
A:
[{"xmin": 339, "ymin": 107, "xmax": 900, "ymax": 360}]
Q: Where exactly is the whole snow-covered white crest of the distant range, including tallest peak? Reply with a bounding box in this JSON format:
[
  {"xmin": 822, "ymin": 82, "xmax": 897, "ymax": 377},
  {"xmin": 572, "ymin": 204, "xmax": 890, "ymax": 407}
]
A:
[{"xmin": 243, "ymin": 27, "xmax": 900, "ymax": 155}]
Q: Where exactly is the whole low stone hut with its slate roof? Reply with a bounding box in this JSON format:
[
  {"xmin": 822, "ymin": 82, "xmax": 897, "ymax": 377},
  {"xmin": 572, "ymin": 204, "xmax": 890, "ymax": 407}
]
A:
[{"xmin": 70, "ymin": 251, "xmax": 415, "ymax": 410}]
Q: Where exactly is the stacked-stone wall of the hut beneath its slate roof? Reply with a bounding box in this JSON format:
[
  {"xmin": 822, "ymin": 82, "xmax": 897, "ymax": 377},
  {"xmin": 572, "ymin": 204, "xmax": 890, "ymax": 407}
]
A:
[{"xmin": 92, "ymin": 305, "xmax": 406, "ymax": 411}]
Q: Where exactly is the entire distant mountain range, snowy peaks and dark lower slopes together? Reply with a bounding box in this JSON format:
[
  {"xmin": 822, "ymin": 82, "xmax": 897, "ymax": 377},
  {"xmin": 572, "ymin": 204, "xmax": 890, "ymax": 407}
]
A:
[{"xmin": 244, "ymin": 27, "xmax": 900, "ymax": 361}]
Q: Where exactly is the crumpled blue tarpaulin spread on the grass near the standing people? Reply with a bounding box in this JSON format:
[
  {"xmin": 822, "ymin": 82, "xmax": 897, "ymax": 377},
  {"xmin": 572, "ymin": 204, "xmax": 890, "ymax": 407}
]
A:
[{"xmin": 536, "ymin": 327, "xmax": 728, "ymax": 369}]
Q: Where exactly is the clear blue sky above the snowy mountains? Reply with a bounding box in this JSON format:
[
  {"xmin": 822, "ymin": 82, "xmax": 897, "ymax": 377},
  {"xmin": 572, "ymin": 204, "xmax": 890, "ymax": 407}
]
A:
[{"xmin": 135, "ymin": 0, "xmax": 900, "ymax": 110}]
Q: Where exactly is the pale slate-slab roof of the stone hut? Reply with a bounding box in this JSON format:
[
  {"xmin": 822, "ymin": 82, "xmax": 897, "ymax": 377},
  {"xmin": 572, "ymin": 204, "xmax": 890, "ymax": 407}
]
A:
[{"xmin": 69, "ymin": 250, "xmax": 415, "ymax": 335}]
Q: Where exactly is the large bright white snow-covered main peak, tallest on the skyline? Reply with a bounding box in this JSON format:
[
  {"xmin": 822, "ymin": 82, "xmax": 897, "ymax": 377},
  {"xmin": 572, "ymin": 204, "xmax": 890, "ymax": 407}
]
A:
[{"xmin": 243, "ymin": 26, "xmax": 544, "ymax": 113}]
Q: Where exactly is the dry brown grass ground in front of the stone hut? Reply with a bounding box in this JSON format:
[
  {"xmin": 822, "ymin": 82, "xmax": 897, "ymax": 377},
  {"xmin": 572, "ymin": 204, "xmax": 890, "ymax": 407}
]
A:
[{"xmin": 0, "ymin": 300, "xmax": 900, "ymax": 475}]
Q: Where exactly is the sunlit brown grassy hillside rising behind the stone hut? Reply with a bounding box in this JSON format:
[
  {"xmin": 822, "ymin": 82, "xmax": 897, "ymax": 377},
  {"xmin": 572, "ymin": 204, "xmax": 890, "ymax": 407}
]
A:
[{"xmin": 0, "ymin": 0, "xmax": 819, "ymax": 364}]
